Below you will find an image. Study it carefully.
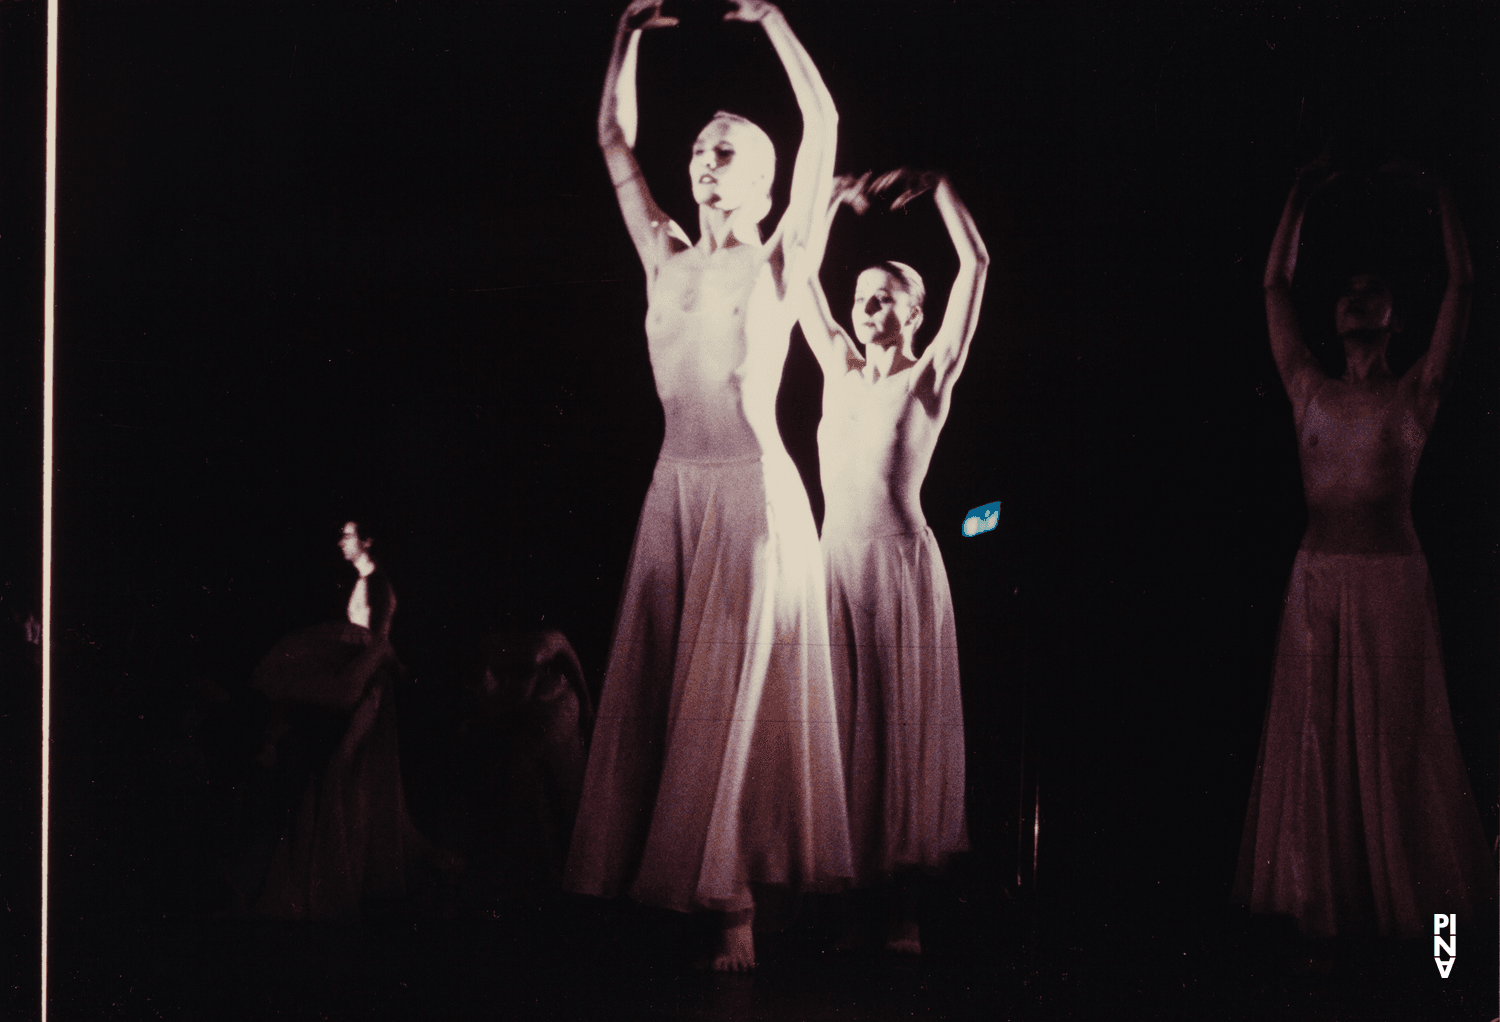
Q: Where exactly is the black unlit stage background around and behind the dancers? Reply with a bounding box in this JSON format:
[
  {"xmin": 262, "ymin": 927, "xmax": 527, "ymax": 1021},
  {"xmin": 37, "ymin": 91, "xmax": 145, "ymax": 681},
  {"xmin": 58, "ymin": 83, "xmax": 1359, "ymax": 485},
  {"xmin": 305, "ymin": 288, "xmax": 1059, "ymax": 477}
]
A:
[{"xmin": 11, "ymin": 2, "xmax": 1500, "ymax": 1017}]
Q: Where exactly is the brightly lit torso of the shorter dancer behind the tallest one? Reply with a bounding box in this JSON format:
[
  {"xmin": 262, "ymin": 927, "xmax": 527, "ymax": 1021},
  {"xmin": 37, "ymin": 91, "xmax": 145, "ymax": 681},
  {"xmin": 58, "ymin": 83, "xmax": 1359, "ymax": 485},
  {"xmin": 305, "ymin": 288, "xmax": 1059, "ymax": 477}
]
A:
[{"xmin": 818, "ymin": 358, "xmax": 948, "ymax": 536}]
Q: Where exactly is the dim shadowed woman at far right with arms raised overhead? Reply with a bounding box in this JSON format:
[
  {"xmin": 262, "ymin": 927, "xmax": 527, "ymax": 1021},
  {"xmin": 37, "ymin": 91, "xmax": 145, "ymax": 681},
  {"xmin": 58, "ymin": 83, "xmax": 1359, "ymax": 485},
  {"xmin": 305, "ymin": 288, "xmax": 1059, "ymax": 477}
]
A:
[{"xmin": 1235, "ymin": 155, "xmax": 1494, "ymax": 936}]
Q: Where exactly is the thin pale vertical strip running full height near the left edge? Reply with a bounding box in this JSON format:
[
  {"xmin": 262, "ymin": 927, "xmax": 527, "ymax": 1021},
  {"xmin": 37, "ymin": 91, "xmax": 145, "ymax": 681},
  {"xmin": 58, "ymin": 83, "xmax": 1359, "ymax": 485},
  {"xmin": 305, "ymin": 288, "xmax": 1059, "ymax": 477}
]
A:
[{"xmin": 42, "ymin": 0, "xmax": 57, "ymax": 1022}]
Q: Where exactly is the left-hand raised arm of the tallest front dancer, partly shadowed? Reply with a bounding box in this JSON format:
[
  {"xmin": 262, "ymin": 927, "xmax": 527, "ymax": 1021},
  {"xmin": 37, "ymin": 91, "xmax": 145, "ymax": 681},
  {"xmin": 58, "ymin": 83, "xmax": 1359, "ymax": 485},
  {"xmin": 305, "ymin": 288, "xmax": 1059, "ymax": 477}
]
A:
[{"xmin": 599, "ymin": 0, "xmax": 686, "ymax": 276}]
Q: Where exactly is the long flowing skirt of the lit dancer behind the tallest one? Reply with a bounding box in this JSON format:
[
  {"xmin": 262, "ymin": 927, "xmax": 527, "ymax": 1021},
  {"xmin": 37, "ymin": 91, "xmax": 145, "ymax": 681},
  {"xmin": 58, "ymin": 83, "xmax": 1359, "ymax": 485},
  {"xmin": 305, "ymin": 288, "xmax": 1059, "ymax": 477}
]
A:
[{"xmin": 824, "ymin": 528, "xmax": 969, "ymax": 885}]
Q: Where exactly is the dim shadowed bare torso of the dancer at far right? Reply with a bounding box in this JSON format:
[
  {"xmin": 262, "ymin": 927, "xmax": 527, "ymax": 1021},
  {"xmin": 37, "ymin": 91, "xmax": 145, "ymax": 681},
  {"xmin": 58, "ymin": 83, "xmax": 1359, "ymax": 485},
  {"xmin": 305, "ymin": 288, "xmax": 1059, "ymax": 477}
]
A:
[{"xmin": 1298, "ymin": 380, "xmax": 1427, "ymax": 554}]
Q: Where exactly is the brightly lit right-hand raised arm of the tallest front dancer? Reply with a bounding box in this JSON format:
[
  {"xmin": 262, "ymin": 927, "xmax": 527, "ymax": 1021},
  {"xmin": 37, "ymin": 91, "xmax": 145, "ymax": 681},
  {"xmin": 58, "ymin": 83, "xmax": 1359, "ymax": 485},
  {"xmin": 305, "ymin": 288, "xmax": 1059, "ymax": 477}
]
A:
[{"xmin": 725, "ymin": 0, "xmax": 839, "ymax": 262}]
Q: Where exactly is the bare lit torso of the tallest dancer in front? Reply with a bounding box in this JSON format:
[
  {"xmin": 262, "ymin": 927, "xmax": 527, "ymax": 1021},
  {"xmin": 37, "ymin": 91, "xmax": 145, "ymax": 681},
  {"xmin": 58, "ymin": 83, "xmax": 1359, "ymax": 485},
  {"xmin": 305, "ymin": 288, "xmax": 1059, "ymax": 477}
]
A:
[{"xmin": 647, "ymin": 237, "xmax": 792, "ymax": 461}]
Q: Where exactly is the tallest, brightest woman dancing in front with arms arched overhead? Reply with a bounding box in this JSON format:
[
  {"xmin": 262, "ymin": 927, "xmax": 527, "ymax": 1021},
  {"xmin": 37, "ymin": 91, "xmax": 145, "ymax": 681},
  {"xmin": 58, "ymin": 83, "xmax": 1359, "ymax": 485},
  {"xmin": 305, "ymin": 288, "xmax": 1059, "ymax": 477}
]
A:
[{"xmin": 564, "ymin": 0, "xmax": 851, "ymax": 969}]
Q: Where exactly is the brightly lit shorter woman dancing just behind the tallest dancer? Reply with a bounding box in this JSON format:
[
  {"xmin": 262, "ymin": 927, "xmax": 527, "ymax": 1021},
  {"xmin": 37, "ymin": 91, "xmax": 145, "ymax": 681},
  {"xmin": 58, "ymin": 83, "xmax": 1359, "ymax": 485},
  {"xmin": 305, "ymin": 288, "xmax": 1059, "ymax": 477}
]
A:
[{"xmin": 803, "ymin": 171, "xmax": 990, "ymax": 953}]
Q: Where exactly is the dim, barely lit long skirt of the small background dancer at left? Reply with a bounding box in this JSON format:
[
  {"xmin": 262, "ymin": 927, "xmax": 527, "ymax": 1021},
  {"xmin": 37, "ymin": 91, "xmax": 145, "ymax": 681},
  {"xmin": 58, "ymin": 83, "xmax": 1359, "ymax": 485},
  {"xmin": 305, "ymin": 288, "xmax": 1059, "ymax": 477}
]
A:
[{"xmin": 251, "ymin": 623, "xmax": 410, "ymax": 918}]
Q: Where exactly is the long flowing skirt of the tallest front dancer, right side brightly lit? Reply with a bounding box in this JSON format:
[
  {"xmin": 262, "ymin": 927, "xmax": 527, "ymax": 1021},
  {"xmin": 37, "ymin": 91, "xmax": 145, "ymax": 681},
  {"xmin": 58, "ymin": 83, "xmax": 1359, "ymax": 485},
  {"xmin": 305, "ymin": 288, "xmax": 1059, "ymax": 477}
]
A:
[{"xmin": 564, "ymin": 456, "xmax": 851, "ymax": 911}]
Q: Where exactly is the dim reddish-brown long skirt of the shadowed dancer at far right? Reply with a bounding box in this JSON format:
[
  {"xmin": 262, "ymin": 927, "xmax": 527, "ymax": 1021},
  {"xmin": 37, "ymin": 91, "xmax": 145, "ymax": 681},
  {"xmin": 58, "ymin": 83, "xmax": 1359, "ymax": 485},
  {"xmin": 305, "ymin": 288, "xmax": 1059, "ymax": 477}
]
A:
[{"xmin": 1235, "ymin": 551, "xmax": 1496, "ymax": 936}]
